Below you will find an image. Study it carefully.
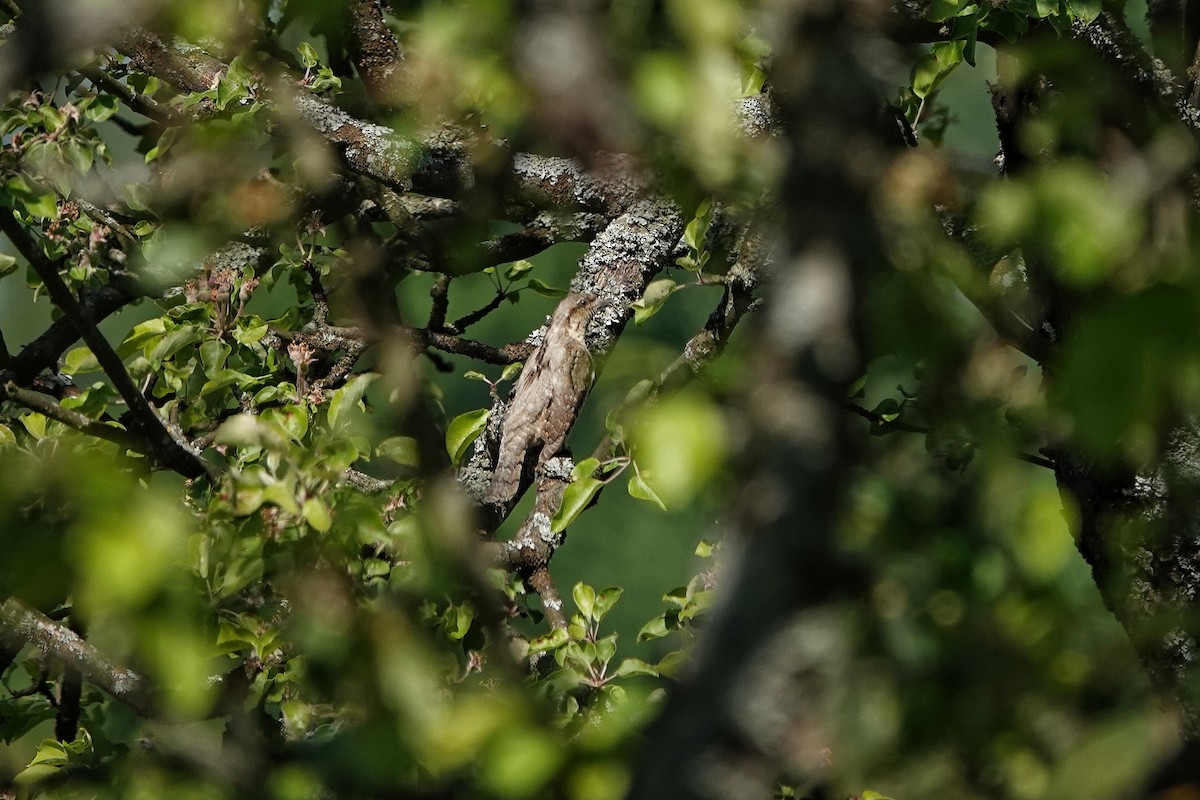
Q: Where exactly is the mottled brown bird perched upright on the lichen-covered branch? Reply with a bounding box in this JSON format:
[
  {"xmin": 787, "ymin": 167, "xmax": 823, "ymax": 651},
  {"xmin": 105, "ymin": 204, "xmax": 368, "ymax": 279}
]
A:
[{"xmin": 484, "ymin": 294, "xmax": 604, "ymax": 504}]
